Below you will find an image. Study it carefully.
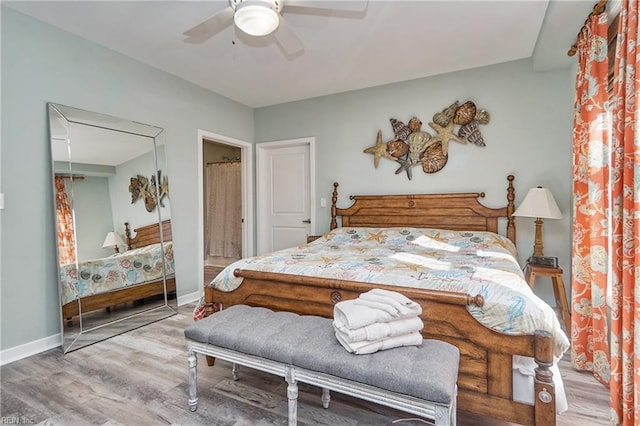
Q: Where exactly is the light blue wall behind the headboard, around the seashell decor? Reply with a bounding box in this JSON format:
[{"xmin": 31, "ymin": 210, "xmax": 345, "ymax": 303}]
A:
[{"xmin": 255, "ymin": 59, "xmax": 573, "ymax": 301}]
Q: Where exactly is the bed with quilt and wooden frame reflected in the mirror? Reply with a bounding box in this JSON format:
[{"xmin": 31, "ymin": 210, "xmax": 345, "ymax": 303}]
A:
[{"xmin": 60, "ymin": 220, "xmax": 176, "ymax": 319}]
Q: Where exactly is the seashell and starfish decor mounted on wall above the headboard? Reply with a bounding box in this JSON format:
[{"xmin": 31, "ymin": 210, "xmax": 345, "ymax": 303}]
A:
[{"xmin": 364, "ymin": 101, "xmax": 489, "ymax": 180}]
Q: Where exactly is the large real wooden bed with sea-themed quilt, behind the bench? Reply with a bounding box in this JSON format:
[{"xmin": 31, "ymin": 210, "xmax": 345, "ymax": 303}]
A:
[{"xmin": 205, "ymin": 175, "xmax": 568, "ymax": 425}]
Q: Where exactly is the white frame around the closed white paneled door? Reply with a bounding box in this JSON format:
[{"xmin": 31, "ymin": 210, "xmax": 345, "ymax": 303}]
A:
[{"xmin": 256, "ymin": 137, "xmax": 316, "ymax": 255}]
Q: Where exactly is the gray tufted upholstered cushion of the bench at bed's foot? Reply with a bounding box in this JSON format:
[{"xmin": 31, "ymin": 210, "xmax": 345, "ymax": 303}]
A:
[{"xmin": 185, "ymin": 305, "xmax": 460, "ymax": 404}]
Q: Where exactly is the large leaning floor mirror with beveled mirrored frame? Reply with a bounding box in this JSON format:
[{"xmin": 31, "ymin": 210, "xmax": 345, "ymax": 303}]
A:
[{"xmin": 48, "ymin": 103, "xmax": 177, "ymax": 353}]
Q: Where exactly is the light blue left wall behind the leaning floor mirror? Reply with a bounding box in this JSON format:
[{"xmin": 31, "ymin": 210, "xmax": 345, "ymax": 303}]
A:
[{"xmin": 0, "ymin": 7, "xmax": 254, "ymax": 350}]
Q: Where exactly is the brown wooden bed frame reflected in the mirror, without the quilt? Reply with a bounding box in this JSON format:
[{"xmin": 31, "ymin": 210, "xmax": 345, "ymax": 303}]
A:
[{"xmin": 62, "ymin": 220, "xmax": 176, "ymax": 319}]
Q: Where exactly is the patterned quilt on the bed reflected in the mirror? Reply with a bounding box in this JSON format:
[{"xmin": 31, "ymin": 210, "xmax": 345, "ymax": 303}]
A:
[{"xmin": 60, "ymin": 241, "xmax": 174, "ymax": 305}]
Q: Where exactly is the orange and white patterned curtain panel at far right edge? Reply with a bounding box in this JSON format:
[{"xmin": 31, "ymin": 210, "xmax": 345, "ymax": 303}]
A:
[{"xmin": 611, "ymin": 0, "xmax": 640, "ymax": 425}]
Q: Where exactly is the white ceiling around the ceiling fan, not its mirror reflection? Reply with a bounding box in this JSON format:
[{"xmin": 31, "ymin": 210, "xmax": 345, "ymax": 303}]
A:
[{"xmin": 3, "ymin": 0, "xmax": 595, "ymax": 107}]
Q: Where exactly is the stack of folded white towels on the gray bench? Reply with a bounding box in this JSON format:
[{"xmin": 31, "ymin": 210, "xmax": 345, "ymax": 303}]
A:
[{"xmin": 333, "ymin": 289, "xmax": 424, "ymax": 355}]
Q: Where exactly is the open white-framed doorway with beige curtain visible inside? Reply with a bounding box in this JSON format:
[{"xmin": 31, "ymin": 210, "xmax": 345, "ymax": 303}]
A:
[{"xmin": 198, "ymin": 131, "xmax": 253, "ymax": 285}]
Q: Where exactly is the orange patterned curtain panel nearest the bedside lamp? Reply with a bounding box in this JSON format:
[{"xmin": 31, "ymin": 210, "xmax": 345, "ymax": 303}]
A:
[{"xmin": 571, "ymin": 13, "xmax": 610, "ymax": 384}]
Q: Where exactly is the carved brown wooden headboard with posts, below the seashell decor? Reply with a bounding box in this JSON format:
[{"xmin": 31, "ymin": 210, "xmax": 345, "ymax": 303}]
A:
[{"xmin": 331, "ymin": 175, "xmax": 516, "ymax": 244}]
